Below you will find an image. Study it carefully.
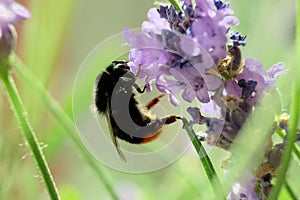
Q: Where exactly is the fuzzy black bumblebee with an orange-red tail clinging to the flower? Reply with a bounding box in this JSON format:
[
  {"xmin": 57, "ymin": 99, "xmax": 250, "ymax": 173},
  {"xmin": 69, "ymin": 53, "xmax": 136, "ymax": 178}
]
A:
[{"xmin": 94, "ymin": 61, "xmax": 181, "ymax": 160}]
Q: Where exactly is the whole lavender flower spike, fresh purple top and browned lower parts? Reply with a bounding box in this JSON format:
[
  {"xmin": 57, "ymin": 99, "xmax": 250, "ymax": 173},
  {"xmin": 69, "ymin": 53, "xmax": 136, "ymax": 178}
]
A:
[{"xmin": 123, "ymin": 0, "xmax": 288, "ymax": 199}]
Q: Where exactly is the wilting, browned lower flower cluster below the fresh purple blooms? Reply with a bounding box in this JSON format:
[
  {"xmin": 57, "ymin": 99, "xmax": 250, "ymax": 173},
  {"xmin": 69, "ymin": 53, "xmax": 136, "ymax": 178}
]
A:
[{"xmin": 188, "ymin": 59, "xmax": 287, "ymax": 149}]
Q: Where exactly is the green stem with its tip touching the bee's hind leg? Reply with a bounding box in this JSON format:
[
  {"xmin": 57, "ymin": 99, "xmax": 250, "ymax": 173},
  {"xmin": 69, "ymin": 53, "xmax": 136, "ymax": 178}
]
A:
[{"xmin": 182, "ymin": 118, "xmax": 225, "ymax": 199}]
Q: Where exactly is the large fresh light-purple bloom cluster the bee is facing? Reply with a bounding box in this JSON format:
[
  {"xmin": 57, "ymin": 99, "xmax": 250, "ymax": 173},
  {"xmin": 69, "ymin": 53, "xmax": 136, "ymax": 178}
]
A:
[{"xmin": 123, "ymin": 0, "xmax": 239, "ymax": 105}]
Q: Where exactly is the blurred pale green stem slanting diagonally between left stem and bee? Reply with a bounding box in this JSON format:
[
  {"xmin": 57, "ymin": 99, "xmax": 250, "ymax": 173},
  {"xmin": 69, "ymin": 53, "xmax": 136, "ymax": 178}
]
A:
[{"xmin": 14, "ymin": 55, "xmax": 118, "ymax": 199}]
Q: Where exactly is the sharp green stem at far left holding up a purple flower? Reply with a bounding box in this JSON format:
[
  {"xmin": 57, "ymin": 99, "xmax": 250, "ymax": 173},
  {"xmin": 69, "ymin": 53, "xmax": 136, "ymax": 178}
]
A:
[{"xmin": 0, "ymin": 70, "xmax": 60, "ymax": 200}]
